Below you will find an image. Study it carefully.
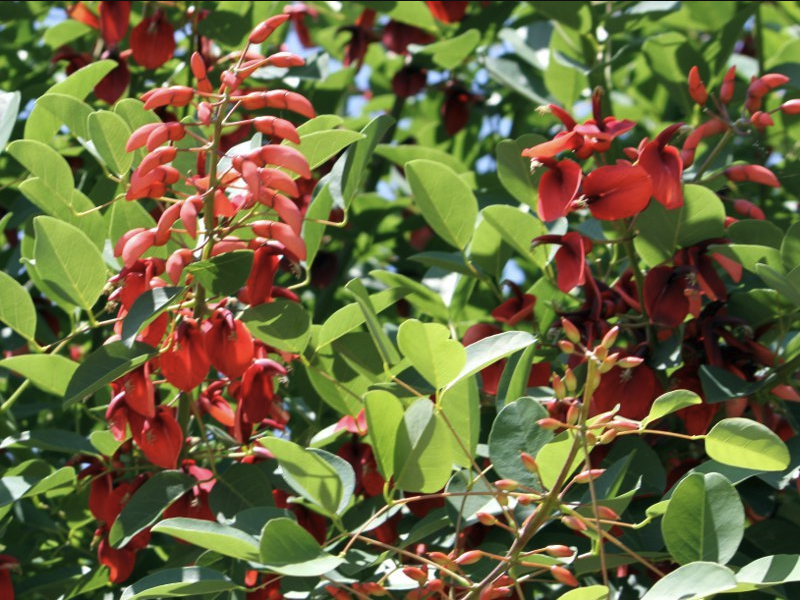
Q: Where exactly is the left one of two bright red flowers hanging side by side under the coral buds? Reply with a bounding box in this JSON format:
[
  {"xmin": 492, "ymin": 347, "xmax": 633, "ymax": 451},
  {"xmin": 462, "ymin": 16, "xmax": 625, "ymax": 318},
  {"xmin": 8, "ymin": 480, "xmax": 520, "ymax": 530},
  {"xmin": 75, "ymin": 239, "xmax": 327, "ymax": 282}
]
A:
[{"xmin": 159, "ymin": 318, "xmax": 211, "ymax": 392}]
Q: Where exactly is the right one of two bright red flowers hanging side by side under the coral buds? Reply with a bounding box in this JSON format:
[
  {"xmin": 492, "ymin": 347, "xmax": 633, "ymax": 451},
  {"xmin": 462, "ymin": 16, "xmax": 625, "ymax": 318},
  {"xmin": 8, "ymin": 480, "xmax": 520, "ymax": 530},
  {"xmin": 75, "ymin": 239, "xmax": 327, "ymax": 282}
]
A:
[{"xmin": 205, "ymin": 308, "xmax": 255, "ymax": 379}]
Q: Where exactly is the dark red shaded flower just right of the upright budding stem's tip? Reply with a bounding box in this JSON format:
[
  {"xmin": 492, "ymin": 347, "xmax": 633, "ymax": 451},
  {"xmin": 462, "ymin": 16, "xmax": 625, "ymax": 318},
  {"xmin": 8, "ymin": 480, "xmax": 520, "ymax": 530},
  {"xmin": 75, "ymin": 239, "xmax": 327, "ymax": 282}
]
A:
[{"xmin": 590, "ymin": 364, "xmax": 662, "ymax": 421}]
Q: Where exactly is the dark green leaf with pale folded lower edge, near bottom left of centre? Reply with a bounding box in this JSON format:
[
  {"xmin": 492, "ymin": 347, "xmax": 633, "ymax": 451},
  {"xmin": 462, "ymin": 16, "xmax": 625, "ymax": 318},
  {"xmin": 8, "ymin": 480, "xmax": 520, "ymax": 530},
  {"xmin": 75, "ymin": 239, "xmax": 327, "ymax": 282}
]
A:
[{"xmin": 261, "ymin": 518, "xmax": 344, "ymax": 577}]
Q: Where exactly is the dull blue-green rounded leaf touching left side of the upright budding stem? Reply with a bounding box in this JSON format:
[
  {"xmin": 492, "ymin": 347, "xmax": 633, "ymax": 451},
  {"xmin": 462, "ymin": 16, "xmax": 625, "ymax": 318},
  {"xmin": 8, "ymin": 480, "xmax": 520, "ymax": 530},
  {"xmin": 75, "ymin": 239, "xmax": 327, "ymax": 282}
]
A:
[{"xmin": 489, "ymin": 397, "xmax": 554, "ymax": 487}]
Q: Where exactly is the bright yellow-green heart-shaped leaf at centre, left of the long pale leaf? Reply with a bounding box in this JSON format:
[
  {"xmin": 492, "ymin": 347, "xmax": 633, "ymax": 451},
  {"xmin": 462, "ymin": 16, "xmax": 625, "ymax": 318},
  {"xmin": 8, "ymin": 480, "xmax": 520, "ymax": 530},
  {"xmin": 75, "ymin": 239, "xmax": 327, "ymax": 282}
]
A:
[{"xmin": 397, "ymin": 319, "xmax": 467, "ymax": 389}]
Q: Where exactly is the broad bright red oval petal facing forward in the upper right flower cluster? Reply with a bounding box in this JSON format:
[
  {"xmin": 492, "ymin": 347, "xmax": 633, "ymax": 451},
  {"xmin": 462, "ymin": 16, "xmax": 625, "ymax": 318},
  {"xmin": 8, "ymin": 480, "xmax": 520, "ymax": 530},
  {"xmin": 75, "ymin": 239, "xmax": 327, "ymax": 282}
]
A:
[{"xmin": 583, "ymin": 163, "xmax": 653, "ymax": 221}]
